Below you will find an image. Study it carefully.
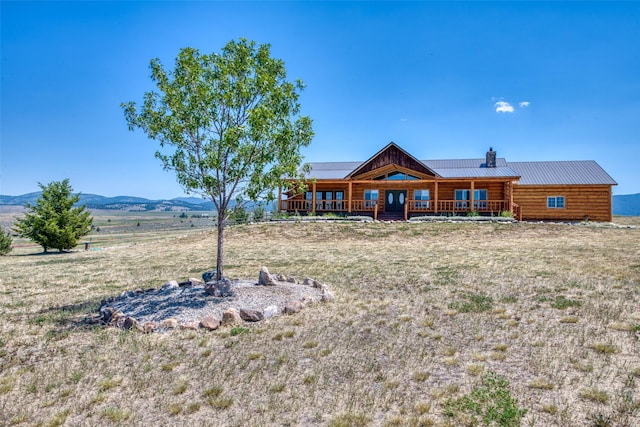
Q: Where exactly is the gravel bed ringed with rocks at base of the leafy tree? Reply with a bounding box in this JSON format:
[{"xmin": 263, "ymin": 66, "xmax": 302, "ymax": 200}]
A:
[{"xmin": 108, "ymin": 280, "xmax": 321, "ymax": 324}]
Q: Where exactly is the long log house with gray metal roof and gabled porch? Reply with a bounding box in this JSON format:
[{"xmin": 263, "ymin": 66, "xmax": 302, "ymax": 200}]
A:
[{"xmin": 278, "ymin": 142, "xmax": 616, "ymax": 221}]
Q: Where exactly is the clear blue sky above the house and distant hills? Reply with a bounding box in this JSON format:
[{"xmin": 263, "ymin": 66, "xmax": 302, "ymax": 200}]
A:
[{"xmin": 0, "ymin": 1, "xmax": 640, "ymax": 199}]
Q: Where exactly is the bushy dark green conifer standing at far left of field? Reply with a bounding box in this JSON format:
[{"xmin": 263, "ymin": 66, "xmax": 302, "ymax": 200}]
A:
[{"xmin": 14, "ymin": 179, "xmax": 93, "ymax": 252}]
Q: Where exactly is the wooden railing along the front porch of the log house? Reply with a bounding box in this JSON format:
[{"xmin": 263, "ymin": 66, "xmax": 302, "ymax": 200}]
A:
[{"xmin": 280, "ymin": 199, "xmax": 520, "ymax": 219}]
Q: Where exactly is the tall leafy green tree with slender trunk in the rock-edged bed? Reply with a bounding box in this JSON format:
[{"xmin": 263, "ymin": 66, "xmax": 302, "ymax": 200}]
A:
[{"xmin": 122, "ymin": 39, "xmax": 313, "ymax": 280}]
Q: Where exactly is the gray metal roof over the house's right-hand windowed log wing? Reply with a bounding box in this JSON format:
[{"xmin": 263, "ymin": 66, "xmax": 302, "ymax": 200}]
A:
[{"xmin": 508, "ymin": 160, "xmax": 617, "ymax": 185}]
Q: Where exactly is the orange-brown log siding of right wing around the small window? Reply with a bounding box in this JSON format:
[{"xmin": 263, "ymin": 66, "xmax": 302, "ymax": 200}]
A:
[{"xmin": 513, "ymin": 184, "xmax": 612, "ymax": 221}]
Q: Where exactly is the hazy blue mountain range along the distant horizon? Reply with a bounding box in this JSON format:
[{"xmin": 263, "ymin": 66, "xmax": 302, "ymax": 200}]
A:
[{"xmin": 0, "ymin": 192, "xmax": 640, "ymax": 216}]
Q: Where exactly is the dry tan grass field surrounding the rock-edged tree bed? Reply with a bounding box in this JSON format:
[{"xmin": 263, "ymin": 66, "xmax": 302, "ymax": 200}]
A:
[{"xmin": 0, "ymin": 216, "xmax": 640, "ymax": 426}]
